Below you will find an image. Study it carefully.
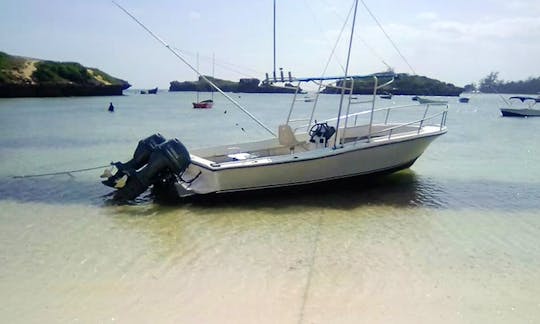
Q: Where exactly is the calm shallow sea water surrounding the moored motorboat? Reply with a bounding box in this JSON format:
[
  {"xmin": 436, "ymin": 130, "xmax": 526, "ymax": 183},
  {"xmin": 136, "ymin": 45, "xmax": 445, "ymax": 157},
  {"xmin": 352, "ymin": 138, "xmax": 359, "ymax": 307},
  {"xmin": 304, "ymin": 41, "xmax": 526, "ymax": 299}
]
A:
[{"xmin": 0, "ymin": 91, "xmax": 540, "ymax": 324}]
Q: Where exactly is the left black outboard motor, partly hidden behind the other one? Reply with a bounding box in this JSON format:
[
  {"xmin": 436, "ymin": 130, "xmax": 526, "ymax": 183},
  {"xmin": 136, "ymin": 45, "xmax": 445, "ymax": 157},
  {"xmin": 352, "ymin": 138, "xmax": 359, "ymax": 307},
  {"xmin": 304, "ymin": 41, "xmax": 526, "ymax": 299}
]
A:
[{"xmin": 102, "ymin": 133, "xmax": 166, "ymax": 188}]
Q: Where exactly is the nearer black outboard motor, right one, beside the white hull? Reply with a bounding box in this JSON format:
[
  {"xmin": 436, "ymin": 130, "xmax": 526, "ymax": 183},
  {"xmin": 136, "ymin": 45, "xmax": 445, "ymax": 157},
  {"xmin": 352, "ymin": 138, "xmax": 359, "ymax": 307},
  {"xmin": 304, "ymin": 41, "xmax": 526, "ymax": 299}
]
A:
[{"xmin": 114, "ymin": 139, "xmax": 191, "ymax": 200}]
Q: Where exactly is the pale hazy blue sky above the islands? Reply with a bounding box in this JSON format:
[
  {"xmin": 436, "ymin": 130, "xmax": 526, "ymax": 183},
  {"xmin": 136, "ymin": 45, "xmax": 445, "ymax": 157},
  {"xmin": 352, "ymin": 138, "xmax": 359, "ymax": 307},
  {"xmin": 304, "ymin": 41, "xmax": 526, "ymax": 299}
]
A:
[{"xmin": 0, "ymin": 0, "xmax": 540, "ymax": 89}]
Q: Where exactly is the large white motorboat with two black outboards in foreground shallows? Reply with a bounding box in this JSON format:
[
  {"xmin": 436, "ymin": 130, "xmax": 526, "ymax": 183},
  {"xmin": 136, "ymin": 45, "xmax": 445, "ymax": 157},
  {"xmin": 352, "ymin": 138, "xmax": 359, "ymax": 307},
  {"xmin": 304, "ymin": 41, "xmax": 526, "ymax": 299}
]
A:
[{"xmin": 103, "ymin": 1, "xmax": 448, "ymax": 200}]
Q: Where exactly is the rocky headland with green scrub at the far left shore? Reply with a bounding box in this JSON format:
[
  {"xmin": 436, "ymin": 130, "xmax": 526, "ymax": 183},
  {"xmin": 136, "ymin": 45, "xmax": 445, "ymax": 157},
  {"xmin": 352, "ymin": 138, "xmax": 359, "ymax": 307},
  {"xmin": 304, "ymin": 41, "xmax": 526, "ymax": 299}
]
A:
[{"xmin": 0, "ymin": 52, "xmax": 130, "ymax": 98}]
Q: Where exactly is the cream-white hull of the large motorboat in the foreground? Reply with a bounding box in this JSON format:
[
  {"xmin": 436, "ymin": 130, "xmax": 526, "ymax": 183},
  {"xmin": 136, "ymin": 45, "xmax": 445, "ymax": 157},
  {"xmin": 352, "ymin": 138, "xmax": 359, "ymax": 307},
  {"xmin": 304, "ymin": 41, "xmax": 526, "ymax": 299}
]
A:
[{"xmin": 176, "ymin": 126, "xmax": 446, "ymax": 196}]
